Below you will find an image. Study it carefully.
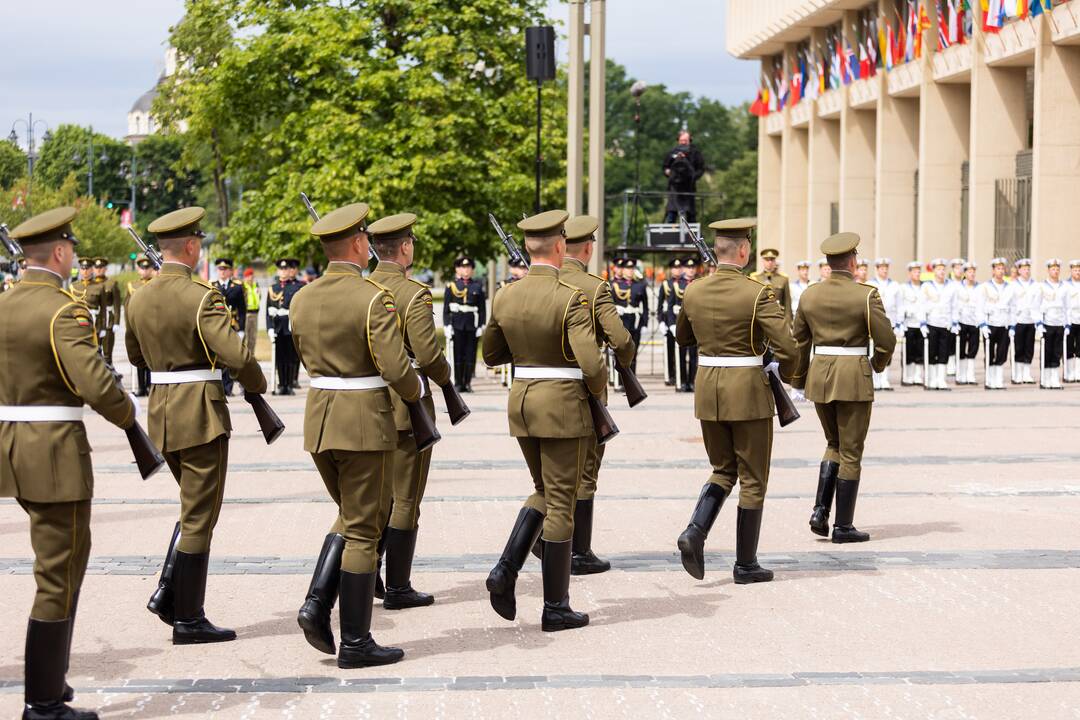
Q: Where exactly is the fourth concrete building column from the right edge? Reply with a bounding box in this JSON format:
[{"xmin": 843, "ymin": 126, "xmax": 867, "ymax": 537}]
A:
[{"xmin": 874, "ymin": 86, "xmax": 919, "ymax": 264}]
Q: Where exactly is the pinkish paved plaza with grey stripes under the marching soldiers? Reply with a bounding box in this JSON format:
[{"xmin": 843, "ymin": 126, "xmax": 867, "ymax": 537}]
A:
[{"xmin": 0, "ymin": 347, "xmax": 1080, "ymax": 719}]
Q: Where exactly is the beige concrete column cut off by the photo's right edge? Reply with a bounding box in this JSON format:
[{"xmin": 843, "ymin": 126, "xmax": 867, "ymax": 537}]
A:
[{"xmin": 1031, "ymin": 22, "xmax": 1080, "ymax": 266}]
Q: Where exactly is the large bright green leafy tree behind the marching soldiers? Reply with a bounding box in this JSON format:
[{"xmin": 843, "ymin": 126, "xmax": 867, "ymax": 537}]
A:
[{"xmin": 156, "ymin": 0, "xmax": 566, "ymax": 267}]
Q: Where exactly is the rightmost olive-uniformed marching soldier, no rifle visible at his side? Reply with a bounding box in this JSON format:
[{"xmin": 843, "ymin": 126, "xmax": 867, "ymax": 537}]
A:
[{"xmin": 792, "ymin": 232, "xmax": 896, "ymax": 543}]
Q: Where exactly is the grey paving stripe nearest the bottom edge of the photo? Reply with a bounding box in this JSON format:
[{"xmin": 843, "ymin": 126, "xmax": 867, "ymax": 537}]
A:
[{"xmin": 0, "ymin": 667, "xmax": 1080, "ymax": 694}]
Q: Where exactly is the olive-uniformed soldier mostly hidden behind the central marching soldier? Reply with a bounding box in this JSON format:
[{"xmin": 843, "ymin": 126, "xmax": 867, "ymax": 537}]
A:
[{"xmin": 558, "ymin": 215, "xmax": 635, "ymax": 575}]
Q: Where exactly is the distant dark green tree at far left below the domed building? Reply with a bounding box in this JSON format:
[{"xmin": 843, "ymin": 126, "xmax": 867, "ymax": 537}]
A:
[{"xmin": 33, "ymin": 124, "xmax": 131, "ymax": 203}]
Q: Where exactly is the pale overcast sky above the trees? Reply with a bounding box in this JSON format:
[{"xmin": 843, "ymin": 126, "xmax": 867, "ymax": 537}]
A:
[{"xmin": 0, "ymin": 0, "xmax": 757, "ymax": 144}]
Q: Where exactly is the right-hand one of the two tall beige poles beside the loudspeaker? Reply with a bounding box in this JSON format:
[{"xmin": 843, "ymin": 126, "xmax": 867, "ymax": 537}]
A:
[{"xmin": 589, "ymin": 0, "xmax": 607, "ymax": 274}]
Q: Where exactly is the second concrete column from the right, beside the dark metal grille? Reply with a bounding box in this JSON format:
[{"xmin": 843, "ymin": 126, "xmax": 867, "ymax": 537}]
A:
[{"xmin": 969, "ymin": 28, "xmax": 1027, "ymax": 266}]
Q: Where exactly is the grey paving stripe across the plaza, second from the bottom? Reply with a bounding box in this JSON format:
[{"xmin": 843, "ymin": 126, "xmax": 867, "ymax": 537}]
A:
[{"xmin": 0, "ymin": 549, "xmax": 1080, "ymax": 575}]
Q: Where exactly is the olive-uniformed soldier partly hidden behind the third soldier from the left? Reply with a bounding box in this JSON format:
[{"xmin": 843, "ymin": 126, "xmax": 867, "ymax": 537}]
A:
[{"xmin": 367, "ymin": 213, "xmax": 453, "ymax": 610}]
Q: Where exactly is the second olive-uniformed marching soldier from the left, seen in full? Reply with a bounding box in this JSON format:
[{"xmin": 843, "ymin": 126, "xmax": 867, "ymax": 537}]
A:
[{"xmin": 125, "ymin": 207, "xmax": 267, "ymax": 644}]
